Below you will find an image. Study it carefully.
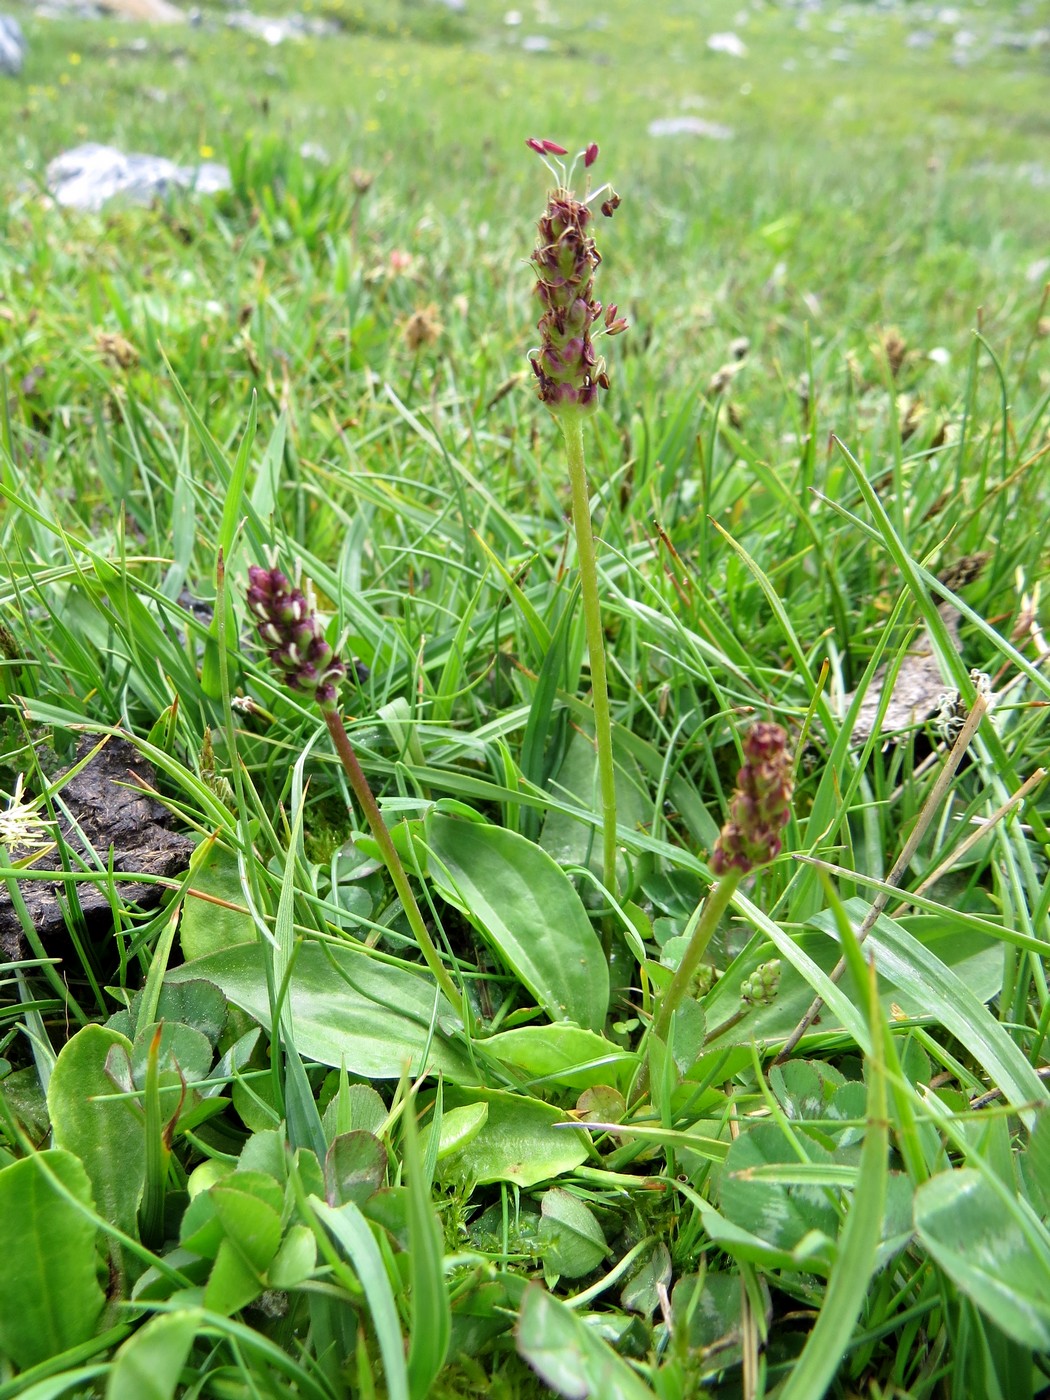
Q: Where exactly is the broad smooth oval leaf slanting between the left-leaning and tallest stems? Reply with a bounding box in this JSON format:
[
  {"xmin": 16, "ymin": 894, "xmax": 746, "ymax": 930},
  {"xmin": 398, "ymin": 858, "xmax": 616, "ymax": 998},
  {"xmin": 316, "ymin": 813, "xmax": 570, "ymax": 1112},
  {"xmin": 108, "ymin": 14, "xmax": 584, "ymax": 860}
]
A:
[{"xmin": 427, "ymin": 813, "xmax": 609, "ymax": 1030}]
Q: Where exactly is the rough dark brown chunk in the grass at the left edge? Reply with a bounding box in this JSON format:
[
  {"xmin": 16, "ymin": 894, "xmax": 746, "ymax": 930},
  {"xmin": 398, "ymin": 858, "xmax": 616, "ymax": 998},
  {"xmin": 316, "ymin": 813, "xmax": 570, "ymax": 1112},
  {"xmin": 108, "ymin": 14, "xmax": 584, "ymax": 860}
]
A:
[{"xmin": 0, "ymin": 735, "xmax": 193, "ymax": 959}]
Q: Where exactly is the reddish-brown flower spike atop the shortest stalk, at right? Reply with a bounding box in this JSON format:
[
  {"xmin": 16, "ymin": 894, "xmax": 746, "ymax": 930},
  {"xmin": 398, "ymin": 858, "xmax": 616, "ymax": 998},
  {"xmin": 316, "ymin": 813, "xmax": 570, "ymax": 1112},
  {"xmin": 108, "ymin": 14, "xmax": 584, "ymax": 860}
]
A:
[{"xmin": 710, "ymin": 721, "xmax": 794, "ymax": 875}]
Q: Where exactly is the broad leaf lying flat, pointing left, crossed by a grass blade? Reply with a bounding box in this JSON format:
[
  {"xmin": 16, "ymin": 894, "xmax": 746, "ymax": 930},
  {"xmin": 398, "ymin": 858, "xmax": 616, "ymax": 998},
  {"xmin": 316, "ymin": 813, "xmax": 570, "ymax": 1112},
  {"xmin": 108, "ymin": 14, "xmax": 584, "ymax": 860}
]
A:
[{"xmin": 167, "ymin": 942, "xmax": 477, "ymax": 1084}]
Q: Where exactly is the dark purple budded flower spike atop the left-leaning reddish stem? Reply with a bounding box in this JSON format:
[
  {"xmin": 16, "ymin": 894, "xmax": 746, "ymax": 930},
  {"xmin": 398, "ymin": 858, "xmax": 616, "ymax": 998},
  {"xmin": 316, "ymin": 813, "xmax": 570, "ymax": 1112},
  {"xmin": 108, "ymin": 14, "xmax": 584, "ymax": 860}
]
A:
[{"xmin": 246, "ymin": 564, "xmax": 346, "ymax": 713}]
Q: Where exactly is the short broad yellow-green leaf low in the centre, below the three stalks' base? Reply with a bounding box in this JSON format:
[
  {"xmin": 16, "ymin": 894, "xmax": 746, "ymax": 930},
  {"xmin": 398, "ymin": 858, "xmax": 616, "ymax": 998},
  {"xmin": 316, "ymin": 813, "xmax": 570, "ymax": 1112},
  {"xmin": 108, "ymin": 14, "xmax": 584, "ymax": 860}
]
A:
[{"xmin": 441, "ymin": 1089, "xmax": 587, "ymax": 1187}]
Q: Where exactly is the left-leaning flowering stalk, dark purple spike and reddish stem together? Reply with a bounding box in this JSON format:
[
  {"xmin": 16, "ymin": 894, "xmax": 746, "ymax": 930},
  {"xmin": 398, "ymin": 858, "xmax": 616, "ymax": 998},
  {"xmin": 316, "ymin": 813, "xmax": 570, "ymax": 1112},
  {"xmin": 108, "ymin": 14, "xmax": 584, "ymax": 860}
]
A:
[{"xmin": 246, "ymin": 566, "xmax": 465, "ymax": 1008}]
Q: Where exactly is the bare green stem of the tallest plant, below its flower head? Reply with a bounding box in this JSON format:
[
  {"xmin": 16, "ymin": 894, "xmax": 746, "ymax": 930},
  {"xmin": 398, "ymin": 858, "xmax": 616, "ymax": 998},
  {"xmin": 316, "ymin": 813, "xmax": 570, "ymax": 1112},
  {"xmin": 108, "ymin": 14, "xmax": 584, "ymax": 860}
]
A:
[{"xmin": 568, "ymin": 413, "xmax": 616, "ymax": 929}]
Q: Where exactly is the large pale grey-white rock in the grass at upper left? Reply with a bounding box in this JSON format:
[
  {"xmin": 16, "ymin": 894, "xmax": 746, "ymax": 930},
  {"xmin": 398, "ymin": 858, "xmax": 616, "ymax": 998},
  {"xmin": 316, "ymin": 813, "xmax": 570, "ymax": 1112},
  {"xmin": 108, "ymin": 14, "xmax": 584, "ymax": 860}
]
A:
[{"xmin": 48, "ymin": 141, "xmax": 230, "ymax": 213}]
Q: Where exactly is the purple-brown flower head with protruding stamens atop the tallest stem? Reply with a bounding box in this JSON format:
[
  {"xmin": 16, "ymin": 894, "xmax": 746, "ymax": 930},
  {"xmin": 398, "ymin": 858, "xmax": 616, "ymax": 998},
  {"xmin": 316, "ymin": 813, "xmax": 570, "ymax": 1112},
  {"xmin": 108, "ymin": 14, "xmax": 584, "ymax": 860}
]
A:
[{"xmin": 526, "ymin": 137, "xmax": 627, "ymax": 416}]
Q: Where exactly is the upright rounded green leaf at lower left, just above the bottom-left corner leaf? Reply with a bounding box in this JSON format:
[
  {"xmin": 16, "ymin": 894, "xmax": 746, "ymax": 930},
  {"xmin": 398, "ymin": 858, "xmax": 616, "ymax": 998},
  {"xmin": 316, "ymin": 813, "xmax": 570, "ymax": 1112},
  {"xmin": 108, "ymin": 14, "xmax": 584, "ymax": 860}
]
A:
[{"xmin": 48, "ymin": 1026, "xmax": 146, "ymax": 1236}]
